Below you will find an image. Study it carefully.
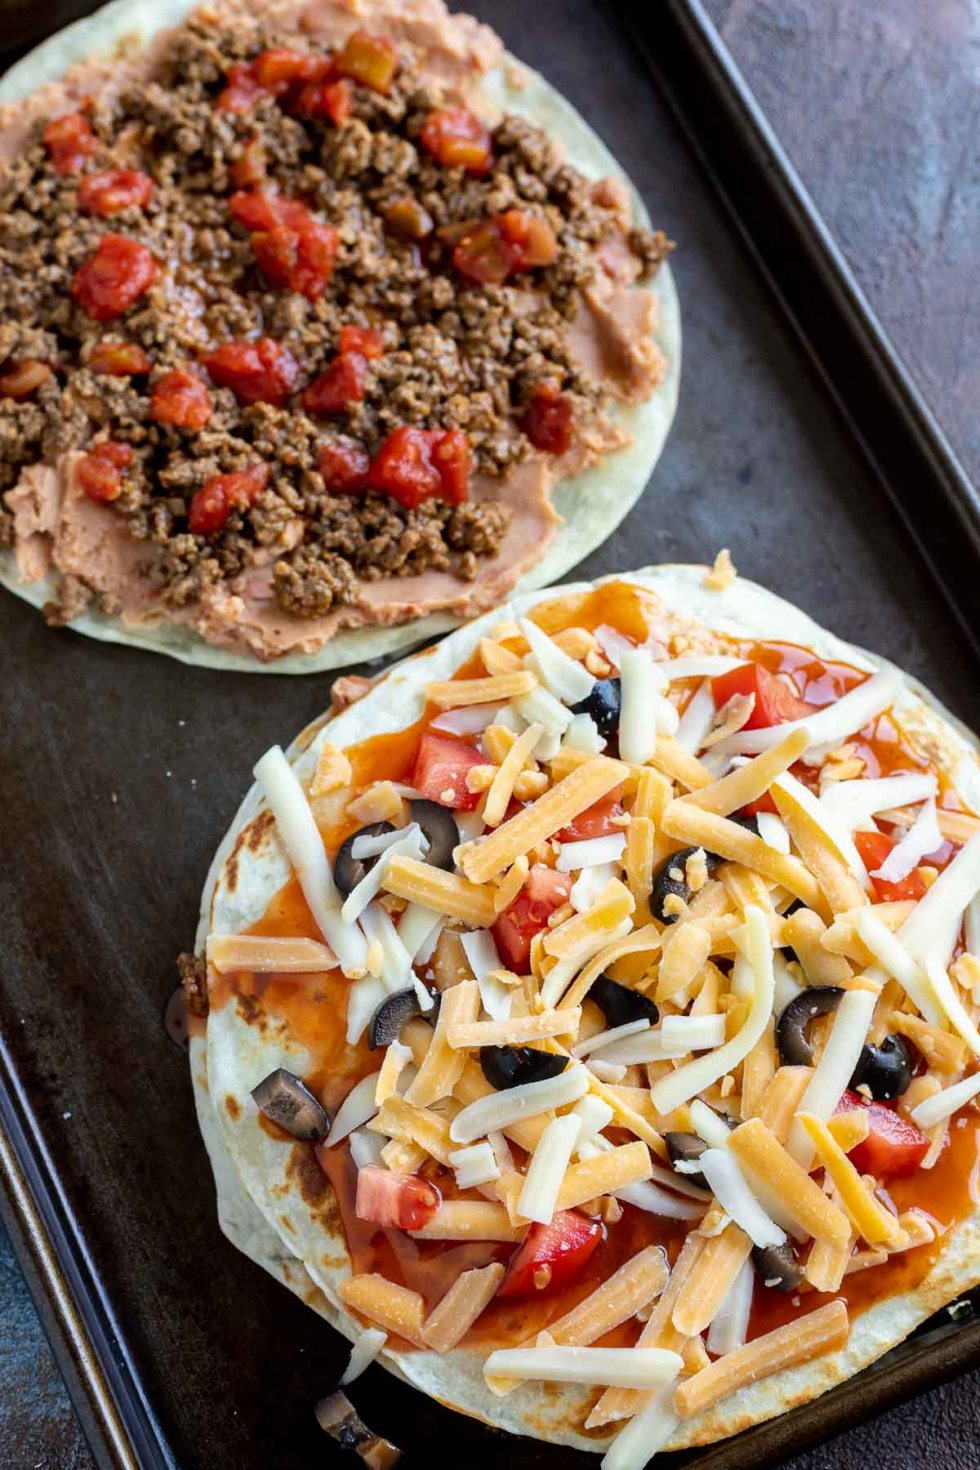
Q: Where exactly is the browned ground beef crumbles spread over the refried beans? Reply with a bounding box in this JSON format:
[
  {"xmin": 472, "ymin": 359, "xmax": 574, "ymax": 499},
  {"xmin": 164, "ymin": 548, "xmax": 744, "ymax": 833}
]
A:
[{"xmin": 0, "ymin": 19, "xmax": 670, "ymax": 622}]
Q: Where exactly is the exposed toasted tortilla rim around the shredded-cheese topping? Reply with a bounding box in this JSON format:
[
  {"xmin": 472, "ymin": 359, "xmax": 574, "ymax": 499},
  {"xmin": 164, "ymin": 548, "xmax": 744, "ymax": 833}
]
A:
[{"xmin": 194, "ymin": 566, "xmax": 980, "ymax": 1449}]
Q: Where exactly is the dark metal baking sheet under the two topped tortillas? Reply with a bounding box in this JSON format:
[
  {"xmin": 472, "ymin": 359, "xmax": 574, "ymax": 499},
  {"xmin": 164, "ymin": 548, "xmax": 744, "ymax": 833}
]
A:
[{"xmin": 0, "ymin": 0, "xmax": 980, "ymax": 1470}]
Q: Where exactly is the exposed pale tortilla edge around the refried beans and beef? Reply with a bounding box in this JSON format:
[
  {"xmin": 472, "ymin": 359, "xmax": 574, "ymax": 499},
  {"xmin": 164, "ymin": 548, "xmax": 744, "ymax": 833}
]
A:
[{"xmin": 0, "ymin": 0, "xmax": 680, "ymax": 673}]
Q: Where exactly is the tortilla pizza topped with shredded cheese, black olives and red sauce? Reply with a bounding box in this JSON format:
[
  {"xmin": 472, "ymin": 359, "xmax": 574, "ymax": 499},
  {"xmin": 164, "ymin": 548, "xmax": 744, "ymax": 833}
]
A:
[{"xmin": 187, "ymin": 559, "xmax": 980, "ymax": 1470}]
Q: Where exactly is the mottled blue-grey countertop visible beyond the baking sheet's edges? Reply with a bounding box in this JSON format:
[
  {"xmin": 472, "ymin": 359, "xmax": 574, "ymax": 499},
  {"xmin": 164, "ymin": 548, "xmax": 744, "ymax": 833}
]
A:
[{"xmin": 0, "ymin": 0, "xmax": 980, "ymax": 1470}]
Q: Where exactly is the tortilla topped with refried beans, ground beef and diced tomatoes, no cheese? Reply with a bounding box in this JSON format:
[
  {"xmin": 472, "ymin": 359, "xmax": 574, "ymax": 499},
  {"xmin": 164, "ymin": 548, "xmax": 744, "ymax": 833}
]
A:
[{"xmin": 0, "ymin": 0, "xmax": 679, "ymax": 667}]
